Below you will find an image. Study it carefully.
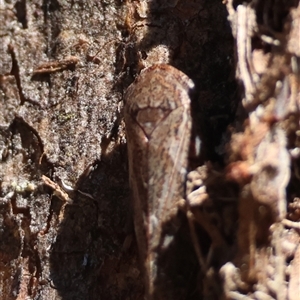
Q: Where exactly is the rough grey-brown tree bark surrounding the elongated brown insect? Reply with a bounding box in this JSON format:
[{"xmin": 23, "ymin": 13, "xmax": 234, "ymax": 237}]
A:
[{"xmin": 0, "ymin": 0, "xmax": 300, "ymax": 300}]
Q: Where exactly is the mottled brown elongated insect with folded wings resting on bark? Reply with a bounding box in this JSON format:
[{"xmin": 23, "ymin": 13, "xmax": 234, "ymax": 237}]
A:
[{"xmin": 124, "ymin": 64, "xmax": 194, "ymax": 299}]
